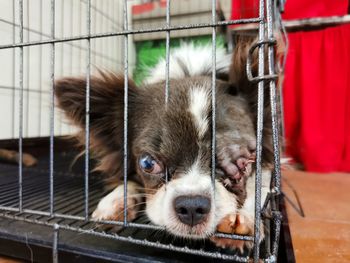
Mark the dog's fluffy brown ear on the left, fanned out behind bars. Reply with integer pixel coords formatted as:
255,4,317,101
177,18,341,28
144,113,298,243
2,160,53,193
55,72,137,179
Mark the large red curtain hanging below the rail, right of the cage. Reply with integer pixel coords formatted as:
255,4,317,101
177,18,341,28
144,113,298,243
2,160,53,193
284,25,350,172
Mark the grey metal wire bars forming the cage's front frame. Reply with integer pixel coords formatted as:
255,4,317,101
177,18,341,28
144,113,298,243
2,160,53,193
0,0,284,262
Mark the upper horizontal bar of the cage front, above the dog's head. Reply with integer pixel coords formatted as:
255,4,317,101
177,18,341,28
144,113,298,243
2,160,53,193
0,18,260,49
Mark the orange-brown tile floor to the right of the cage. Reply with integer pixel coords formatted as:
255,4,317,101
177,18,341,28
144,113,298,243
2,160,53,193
283,171,350,263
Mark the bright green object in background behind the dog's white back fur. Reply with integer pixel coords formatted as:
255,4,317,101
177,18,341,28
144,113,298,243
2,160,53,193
133,35,225,85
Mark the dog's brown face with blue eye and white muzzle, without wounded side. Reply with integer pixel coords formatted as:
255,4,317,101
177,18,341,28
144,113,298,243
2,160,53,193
132,77,241,238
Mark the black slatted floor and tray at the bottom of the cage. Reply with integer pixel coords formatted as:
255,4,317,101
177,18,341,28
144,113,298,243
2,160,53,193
0,139,292,262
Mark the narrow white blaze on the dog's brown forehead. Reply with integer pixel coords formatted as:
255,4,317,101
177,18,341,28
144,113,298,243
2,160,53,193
189,87,210,138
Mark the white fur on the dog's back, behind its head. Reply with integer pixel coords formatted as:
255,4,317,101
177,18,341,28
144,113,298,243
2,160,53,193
145,43,231,84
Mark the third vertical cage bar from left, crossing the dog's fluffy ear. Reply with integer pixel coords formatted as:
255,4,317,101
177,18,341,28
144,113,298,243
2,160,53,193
84,0,91,220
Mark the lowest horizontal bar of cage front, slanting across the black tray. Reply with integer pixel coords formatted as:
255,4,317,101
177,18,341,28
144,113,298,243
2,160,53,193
0,213,249,262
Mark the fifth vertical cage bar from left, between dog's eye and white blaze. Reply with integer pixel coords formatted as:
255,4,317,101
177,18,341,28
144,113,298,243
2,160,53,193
164,0,170,183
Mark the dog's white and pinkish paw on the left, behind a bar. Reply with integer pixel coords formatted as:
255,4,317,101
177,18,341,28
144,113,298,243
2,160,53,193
92,182,142,224
